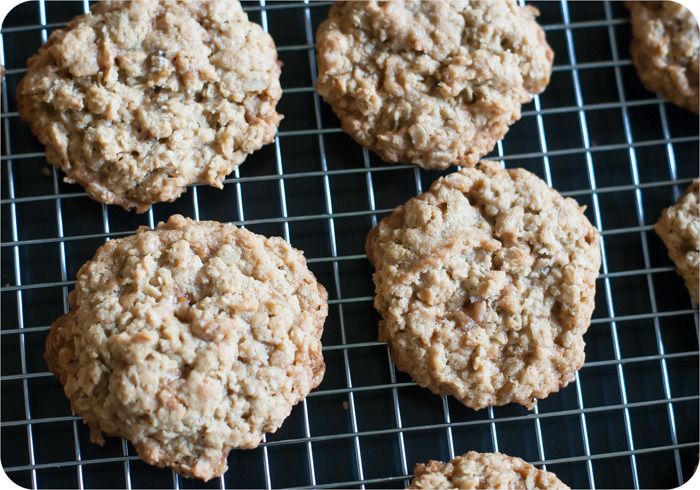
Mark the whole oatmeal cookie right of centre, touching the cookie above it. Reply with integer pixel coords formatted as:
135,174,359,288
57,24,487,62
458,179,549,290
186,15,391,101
366,161,600,409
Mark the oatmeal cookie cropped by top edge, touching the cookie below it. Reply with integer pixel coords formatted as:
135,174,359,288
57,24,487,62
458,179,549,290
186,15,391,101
316,0,553,169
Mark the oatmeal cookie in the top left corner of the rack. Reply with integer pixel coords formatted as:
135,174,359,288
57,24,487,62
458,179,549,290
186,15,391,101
17,0,282,212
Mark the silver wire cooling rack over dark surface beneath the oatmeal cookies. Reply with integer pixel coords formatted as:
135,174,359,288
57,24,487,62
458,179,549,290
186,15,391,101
0,1,698,488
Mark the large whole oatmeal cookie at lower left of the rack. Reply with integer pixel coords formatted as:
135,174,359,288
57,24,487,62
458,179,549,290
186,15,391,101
45,215,328,480
